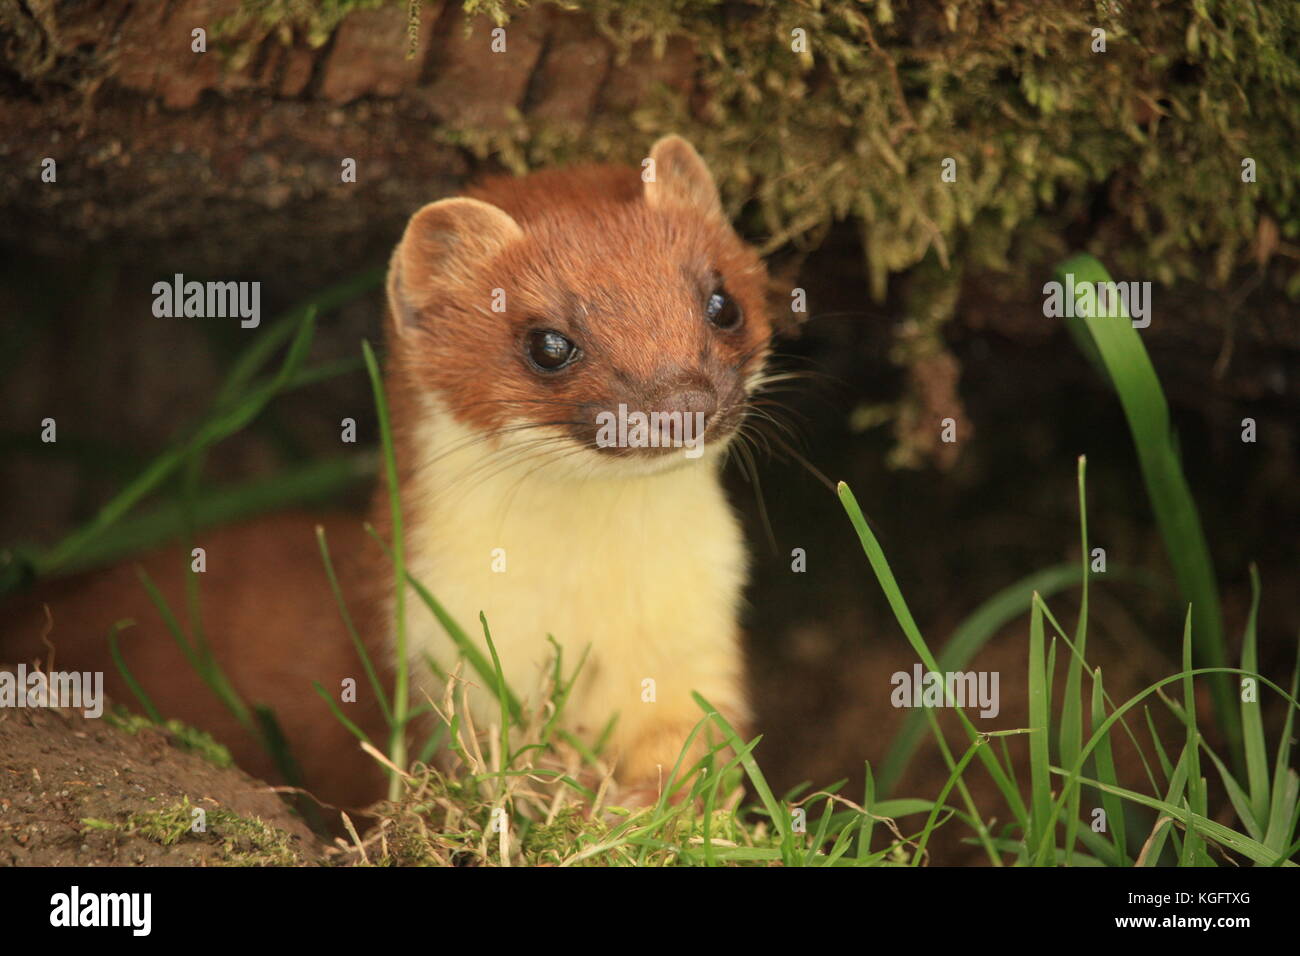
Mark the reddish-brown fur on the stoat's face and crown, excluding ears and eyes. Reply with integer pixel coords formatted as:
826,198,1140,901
390,159,771,440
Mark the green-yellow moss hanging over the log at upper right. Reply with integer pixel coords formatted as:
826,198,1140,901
228,0,1300,299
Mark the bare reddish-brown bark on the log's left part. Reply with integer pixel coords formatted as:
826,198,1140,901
0,0,694,289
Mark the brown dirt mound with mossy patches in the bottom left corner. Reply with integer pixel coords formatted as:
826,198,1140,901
0,708,325,866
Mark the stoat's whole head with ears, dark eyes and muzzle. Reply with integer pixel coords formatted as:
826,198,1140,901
387,137,771,472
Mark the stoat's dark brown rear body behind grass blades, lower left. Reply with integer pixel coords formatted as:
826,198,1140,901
0,514,385,808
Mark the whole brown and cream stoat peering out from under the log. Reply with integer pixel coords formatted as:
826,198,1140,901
0,137,770,806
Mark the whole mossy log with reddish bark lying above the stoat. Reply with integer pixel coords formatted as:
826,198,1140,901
0,0,1300,416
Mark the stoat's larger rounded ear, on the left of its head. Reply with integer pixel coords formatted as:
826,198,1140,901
387,198,524,333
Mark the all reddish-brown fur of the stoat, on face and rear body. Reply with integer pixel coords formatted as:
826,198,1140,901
0,138,770,808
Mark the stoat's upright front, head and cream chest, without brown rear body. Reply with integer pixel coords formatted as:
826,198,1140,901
377,137,770,783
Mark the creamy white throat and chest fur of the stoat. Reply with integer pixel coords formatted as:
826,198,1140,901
390,410,748,774
